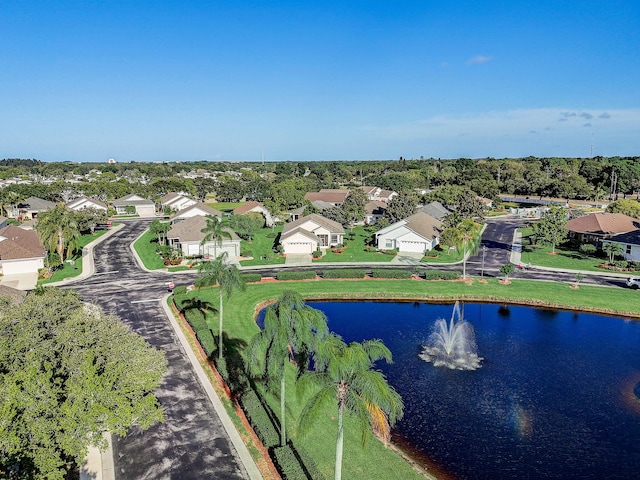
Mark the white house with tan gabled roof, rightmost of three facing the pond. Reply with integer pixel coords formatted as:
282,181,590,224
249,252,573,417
376,212,442,253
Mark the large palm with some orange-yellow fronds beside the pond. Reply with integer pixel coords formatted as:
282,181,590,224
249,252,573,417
298,335,404,480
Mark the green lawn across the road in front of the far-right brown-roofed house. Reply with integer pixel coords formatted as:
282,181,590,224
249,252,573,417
519,228,605,272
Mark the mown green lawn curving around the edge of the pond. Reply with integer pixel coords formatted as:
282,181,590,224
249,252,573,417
178,279,640,480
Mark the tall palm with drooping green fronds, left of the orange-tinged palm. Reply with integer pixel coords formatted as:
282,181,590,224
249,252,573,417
249,290,329,445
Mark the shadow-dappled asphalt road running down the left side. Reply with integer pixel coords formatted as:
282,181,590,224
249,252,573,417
70,220,248,480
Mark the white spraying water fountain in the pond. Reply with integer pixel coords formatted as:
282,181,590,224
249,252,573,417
420,302,482,370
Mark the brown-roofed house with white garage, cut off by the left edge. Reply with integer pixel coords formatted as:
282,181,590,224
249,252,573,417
0,225,46,289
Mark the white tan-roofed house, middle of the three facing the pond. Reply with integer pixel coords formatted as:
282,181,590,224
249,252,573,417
280,213,344,254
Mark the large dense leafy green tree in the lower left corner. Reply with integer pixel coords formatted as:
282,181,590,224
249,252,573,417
0,288,166,480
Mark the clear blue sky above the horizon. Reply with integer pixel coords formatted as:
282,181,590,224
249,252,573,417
0,0,640,162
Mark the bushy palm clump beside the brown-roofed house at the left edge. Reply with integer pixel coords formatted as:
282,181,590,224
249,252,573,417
36,205,80,261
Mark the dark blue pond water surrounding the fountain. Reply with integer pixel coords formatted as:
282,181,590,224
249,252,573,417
258,302,640,480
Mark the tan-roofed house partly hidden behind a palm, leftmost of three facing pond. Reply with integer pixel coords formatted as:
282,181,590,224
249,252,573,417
167,215,240,262
